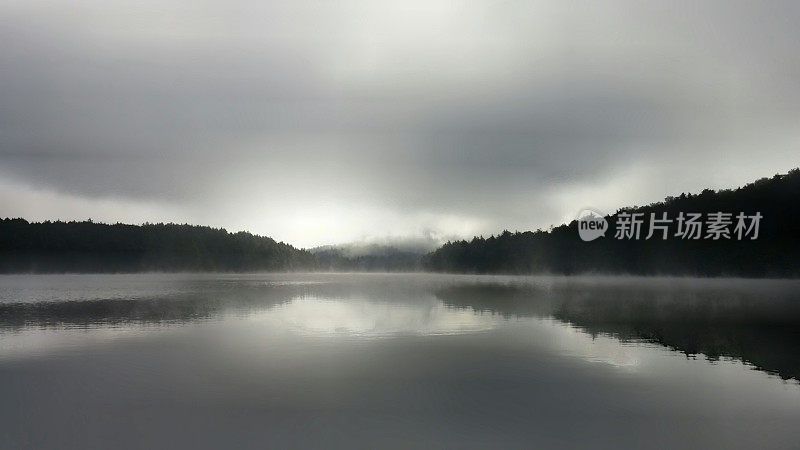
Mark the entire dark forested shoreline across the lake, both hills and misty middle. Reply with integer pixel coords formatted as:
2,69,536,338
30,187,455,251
0,169,800,277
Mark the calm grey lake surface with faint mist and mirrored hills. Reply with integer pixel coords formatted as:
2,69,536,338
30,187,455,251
0,274,800,448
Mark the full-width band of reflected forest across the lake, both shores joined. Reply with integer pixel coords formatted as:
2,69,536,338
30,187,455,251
6,276,800,380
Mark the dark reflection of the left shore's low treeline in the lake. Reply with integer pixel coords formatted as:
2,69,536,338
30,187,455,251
0,283,307,330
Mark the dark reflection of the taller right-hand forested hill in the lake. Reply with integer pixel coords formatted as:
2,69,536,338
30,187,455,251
437,279,800,380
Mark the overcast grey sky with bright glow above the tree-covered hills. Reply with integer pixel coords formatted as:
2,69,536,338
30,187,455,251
0,0,800,247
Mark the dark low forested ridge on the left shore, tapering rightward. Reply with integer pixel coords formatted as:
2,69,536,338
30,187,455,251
0,219,316,273
